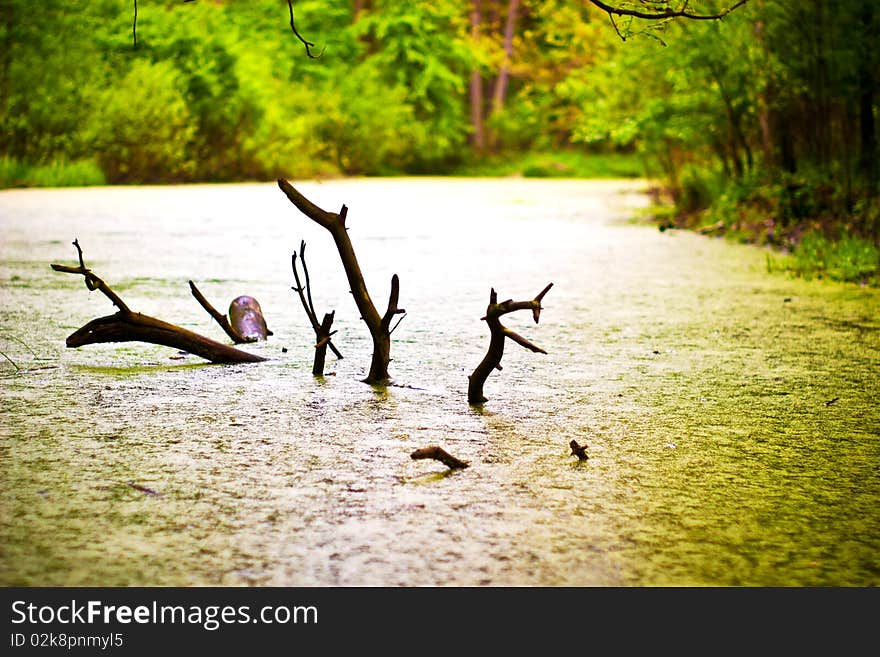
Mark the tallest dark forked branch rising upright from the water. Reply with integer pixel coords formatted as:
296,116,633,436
278,178,406,384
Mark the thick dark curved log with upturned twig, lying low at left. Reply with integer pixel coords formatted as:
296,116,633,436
52,240,266,363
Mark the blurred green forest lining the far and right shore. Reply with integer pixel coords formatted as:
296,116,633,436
0,0,880,284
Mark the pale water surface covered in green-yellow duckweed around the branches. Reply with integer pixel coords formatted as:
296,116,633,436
0,179,880,586
